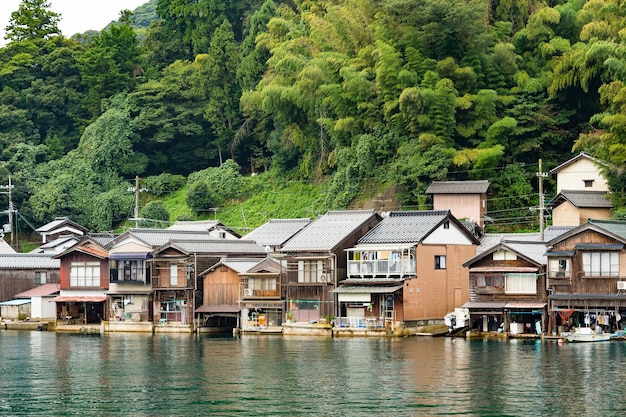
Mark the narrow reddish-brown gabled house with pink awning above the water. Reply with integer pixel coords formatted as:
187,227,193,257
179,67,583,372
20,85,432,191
52,237,109,324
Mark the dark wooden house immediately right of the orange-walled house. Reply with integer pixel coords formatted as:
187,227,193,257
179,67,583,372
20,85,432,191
462,240,548,334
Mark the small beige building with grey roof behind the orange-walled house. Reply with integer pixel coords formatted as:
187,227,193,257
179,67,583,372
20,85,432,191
426,180,491,227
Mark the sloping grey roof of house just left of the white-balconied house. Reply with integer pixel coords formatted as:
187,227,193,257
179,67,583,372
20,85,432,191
281,210,380,252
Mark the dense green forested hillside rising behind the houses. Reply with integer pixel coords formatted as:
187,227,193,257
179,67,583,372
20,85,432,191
0,0,626,236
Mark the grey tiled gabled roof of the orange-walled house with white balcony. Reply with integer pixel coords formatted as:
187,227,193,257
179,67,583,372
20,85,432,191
357,210,479,245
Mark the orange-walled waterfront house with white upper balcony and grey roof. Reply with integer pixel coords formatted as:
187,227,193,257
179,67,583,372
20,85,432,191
333,210,479,327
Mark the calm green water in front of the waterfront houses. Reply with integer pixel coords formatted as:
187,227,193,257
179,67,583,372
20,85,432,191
0,331,626,416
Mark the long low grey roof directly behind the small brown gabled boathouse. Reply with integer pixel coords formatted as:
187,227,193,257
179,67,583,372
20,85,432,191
152,237,265,257
